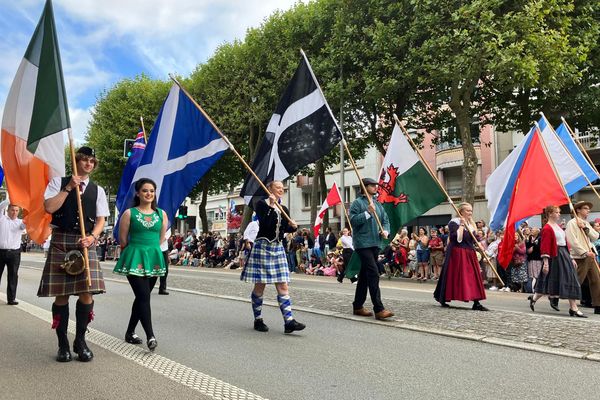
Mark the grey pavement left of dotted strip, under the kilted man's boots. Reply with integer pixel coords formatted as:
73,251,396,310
0,299,237,400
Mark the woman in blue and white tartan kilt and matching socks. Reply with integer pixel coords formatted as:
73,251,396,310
241,181,305,333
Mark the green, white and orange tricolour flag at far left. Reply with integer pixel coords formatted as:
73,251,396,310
1,0,71,243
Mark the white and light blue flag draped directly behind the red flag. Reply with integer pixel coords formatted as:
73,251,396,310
485,117,599,230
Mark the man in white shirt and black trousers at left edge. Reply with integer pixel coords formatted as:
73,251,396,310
0,199,25,306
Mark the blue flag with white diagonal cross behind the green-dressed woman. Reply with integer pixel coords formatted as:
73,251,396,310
115,85,228,239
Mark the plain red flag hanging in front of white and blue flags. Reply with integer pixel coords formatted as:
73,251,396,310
498,129,569,268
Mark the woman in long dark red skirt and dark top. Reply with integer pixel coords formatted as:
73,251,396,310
433,203,488,311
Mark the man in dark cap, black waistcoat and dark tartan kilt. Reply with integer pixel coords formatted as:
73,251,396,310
38,146,109,362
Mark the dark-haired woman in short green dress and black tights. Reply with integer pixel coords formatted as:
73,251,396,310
113,178,168,351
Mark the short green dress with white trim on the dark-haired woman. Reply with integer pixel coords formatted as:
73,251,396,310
113,207,167,276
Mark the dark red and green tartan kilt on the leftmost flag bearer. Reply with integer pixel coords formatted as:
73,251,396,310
38,231,106,297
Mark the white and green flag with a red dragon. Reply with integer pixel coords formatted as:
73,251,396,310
377,125,446,239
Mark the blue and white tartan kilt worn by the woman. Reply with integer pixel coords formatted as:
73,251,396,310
240,238,290,283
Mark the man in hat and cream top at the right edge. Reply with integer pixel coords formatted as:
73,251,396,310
566,201,600,314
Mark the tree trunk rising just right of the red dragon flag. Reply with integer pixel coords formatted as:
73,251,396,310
449,79,478,204
